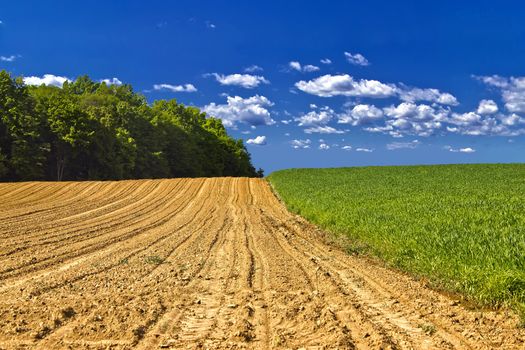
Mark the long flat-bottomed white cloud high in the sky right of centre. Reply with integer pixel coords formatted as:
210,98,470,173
295,74,396,98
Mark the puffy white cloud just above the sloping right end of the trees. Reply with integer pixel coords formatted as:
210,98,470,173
202,95,275,127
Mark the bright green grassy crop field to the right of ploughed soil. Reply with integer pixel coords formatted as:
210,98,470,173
268,164,525,319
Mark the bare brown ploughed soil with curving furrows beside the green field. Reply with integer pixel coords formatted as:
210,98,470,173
0,178,525,349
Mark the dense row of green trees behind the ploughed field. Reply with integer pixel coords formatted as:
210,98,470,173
0,70,262,181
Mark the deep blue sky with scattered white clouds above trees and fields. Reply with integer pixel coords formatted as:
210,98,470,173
0,0,525,173
